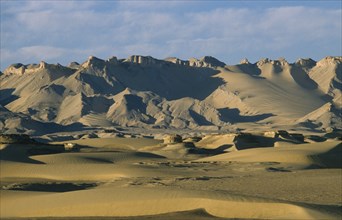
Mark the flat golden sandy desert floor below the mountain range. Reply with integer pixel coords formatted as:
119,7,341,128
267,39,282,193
0,135,342,219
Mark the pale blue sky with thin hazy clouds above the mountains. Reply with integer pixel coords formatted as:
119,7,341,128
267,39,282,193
0,0,342,70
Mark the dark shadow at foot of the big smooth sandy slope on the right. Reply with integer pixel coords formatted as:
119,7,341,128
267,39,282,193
218,108,274,123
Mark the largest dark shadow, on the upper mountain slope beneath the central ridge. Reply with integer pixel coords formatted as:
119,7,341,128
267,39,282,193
108,63,225,100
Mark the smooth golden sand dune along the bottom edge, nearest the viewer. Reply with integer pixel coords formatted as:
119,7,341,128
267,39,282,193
2,187,333,219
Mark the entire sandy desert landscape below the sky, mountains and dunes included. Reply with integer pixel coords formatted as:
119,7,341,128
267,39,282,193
0,55,342,219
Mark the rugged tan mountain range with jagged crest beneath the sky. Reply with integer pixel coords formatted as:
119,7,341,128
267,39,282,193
0,55,342,135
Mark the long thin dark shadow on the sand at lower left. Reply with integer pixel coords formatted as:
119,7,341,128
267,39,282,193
2,182,97,192
